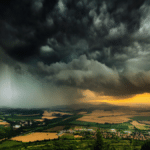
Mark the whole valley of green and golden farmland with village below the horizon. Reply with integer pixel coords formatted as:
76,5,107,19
0,107,149,150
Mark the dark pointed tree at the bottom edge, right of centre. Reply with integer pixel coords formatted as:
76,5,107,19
94,130,104,150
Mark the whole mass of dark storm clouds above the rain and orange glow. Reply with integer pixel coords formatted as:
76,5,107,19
0,0,150,99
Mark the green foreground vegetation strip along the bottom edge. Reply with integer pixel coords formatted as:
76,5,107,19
0,131,149,150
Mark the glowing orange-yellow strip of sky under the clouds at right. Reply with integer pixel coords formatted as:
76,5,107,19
80,90,150,106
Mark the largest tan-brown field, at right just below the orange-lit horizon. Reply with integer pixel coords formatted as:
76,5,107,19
77,110,150,124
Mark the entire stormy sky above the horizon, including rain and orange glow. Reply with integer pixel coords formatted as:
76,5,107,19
0,0,150,108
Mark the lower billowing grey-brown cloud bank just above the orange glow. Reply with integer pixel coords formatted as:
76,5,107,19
38,55,150,98
